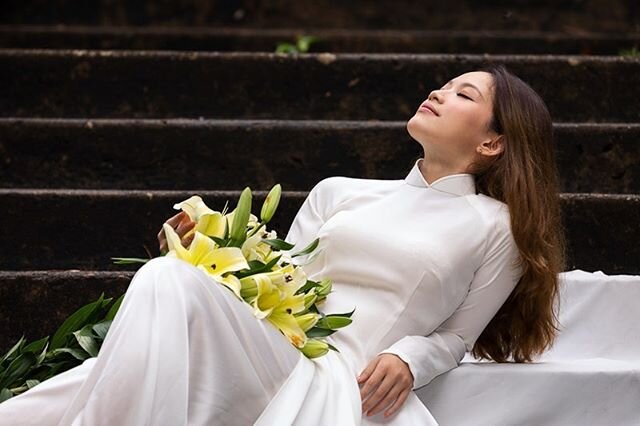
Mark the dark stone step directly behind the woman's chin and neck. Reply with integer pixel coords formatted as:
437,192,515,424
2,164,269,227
0,118,640,193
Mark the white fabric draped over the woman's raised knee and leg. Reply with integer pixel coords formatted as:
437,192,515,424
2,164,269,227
0,257,303,426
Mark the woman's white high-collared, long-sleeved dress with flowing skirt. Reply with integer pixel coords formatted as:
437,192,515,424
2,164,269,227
0,159,521,426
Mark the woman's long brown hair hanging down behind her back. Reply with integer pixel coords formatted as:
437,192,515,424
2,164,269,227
469,64,566,362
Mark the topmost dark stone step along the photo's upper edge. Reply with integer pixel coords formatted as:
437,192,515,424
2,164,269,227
0,0,640,32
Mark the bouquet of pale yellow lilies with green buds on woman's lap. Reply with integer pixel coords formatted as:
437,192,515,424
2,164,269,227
113,184,353,358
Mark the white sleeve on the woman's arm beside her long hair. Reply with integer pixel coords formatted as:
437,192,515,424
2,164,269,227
379,211,521,390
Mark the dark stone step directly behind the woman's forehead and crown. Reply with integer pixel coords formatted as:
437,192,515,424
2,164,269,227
0,49,640,122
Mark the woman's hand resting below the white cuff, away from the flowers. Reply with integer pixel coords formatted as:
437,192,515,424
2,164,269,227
358,353,414,417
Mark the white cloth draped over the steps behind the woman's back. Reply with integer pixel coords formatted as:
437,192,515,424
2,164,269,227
416,269,640,426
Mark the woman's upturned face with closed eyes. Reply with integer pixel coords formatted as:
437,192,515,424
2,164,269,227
407,71,497,167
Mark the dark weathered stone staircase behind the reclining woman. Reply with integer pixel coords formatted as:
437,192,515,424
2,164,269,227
0,0,640,392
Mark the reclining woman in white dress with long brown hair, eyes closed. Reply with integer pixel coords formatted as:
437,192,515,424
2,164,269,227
0,66,564,425
